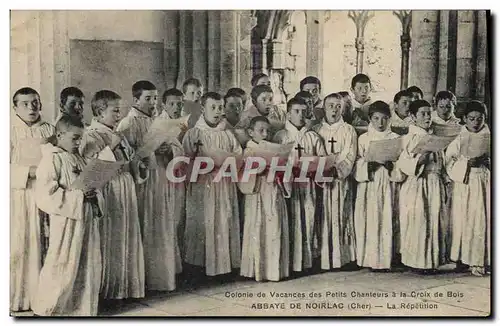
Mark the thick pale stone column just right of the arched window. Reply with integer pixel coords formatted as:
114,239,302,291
409,10,439,101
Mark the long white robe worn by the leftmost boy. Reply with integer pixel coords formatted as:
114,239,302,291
10,113,54,311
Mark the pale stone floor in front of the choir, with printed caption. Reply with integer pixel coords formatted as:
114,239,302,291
12,269,491,317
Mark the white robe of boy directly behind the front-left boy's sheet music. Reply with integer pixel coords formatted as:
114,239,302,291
80,119,145,299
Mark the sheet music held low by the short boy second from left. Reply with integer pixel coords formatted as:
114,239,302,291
71,159,127,190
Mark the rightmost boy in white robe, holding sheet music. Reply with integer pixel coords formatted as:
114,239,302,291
446,101,491,276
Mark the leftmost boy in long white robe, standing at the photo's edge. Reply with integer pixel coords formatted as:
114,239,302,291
10,87,54,311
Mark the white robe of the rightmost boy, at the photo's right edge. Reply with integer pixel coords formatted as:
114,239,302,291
445,125,491,267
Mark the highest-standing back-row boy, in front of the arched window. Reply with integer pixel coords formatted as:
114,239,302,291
351,74,373,126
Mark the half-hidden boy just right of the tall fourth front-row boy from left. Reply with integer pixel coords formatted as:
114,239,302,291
157,88,187,274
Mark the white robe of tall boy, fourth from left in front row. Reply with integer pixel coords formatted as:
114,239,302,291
116,107,176,291
